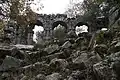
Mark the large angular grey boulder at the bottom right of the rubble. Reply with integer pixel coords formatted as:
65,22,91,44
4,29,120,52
93,62,117,80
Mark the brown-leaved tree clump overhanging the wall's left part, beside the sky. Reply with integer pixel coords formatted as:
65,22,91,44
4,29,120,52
9,0,36,26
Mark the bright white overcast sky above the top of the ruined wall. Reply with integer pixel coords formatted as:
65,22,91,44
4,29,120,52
32,0,83,14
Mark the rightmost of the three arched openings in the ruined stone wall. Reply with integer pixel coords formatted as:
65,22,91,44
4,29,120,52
75,22,89,35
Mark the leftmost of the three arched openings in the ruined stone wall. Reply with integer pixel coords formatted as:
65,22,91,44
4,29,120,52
33,20,44,43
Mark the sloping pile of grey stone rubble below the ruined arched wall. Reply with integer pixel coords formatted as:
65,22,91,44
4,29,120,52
0,24,120,80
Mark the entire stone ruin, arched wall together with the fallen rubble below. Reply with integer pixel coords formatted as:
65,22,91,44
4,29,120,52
0,6,120,80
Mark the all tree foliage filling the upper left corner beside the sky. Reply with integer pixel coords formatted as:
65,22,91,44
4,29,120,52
0,0,42,27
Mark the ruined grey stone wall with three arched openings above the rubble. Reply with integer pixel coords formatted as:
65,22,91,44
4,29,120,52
4,14,108,44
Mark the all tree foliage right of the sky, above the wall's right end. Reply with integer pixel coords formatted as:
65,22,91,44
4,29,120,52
66,0,120,20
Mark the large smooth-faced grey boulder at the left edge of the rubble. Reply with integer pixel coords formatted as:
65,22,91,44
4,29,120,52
0,56,22,71
